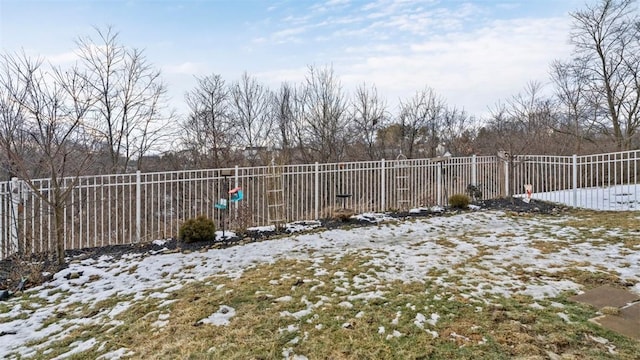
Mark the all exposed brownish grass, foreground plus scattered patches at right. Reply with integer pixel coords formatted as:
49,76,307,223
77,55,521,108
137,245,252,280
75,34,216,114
5,213,640,359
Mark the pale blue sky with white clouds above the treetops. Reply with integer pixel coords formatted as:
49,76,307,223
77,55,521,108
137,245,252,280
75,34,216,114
0,0,595,116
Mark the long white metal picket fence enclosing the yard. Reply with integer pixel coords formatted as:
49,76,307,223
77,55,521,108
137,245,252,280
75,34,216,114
0,151,640,259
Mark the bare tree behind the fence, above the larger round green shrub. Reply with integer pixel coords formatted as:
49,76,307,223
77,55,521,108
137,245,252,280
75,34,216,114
182,75,232,167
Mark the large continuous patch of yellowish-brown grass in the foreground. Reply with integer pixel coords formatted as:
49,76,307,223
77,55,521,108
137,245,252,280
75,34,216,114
61,256,640,359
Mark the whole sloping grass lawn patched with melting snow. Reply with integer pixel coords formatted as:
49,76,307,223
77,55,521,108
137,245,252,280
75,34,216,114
0,211,640,359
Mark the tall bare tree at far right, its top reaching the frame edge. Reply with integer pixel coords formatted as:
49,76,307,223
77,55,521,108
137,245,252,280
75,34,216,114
571,0,640,150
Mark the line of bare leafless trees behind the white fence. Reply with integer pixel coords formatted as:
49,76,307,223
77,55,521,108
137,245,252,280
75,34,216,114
0,0,640,179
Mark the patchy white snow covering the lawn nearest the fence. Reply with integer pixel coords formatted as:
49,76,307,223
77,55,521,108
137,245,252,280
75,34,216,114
0,195,640,359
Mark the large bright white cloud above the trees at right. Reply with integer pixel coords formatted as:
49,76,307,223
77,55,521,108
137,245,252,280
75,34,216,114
336,18,570,114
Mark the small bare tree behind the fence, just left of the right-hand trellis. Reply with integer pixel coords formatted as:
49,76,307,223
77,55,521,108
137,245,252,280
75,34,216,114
351,84,389,160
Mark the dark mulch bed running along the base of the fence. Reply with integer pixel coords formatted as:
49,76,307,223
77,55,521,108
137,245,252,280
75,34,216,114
0,198,568,291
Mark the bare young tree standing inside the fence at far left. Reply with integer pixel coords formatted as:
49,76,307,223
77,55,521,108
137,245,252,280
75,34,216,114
0,51,94,264
